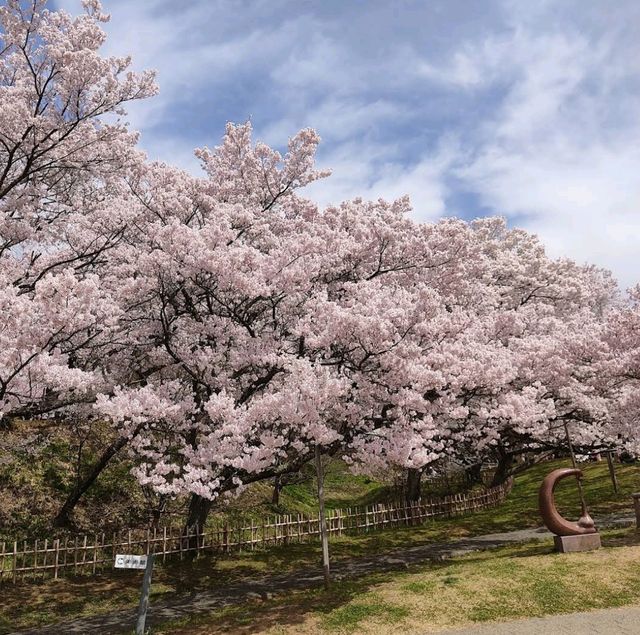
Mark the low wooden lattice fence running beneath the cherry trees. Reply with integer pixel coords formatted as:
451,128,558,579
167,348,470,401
0,480,512,583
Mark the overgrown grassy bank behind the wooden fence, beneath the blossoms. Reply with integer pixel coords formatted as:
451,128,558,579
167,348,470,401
0,421,390,542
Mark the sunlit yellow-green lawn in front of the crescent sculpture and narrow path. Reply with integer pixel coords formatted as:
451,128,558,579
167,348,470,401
153,530,640,635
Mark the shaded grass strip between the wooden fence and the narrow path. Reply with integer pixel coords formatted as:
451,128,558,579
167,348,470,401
0,461,640,632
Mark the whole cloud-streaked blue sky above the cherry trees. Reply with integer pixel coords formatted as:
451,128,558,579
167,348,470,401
54,0,640,286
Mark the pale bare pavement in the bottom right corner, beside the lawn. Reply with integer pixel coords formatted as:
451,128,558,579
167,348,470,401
442,607,640,635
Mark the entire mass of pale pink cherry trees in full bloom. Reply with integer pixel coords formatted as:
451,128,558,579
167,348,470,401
0,0,640,526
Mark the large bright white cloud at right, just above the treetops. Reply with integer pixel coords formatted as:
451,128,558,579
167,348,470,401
438,6,640,286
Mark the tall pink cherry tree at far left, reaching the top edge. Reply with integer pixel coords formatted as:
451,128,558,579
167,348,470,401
0,0,155,422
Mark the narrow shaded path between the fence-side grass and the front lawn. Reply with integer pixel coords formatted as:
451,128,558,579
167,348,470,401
12,516,640,635
